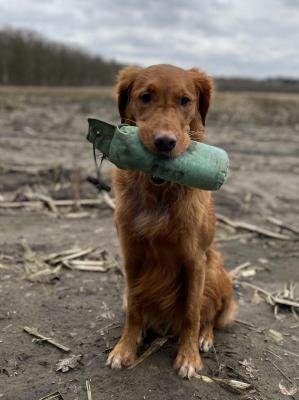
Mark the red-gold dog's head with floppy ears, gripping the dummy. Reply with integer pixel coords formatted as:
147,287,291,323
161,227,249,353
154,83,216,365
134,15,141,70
116,64,213,157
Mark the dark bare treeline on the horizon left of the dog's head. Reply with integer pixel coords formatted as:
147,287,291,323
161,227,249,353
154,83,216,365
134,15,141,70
0,29,121,86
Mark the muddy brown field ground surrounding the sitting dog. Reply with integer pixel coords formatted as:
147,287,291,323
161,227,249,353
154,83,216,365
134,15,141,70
0,88,299,400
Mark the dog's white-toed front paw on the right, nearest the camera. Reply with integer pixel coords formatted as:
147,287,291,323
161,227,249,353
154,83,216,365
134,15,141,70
174,350,202,379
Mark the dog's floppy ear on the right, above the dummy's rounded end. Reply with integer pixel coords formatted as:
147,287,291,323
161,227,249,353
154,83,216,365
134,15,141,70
189,68,214,125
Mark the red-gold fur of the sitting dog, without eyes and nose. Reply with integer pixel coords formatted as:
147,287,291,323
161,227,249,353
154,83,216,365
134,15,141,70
108,65,235,378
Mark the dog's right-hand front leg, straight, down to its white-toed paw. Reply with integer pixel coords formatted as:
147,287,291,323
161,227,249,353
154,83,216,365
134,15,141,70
175,255,205,378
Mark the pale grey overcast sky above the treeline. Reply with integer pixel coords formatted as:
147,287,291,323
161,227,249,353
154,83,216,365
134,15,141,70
0,0,299,78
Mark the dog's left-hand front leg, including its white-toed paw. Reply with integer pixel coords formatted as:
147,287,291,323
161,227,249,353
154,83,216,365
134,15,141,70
107,239,142,368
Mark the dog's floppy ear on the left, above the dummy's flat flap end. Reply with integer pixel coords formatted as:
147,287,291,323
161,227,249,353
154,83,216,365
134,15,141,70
115,67,141,123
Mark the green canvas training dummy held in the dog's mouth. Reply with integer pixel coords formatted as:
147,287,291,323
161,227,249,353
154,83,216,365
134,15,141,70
87,118,229,190
